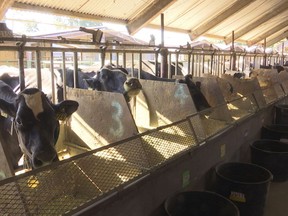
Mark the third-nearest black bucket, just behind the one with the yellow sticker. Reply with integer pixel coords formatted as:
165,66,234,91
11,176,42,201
250,139,288,181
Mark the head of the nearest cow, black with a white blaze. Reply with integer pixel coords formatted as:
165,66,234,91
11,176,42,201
0,88,79,168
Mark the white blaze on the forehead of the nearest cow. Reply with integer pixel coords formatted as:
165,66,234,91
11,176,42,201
23,92,44,120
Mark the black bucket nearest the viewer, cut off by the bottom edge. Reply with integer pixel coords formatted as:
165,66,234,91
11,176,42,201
164,191,240,216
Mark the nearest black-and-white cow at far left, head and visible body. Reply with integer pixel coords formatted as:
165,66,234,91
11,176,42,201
0,81,79,168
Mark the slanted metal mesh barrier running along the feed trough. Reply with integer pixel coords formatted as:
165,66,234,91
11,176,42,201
0,67,288,216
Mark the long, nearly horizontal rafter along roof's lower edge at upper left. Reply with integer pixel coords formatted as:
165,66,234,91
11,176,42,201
12,2,127,25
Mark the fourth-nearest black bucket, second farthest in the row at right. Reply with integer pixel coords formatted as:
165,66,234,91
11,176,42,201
261,124,288,140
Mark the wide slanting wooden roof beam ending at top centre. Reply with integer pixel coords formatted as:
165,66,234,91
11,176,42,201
126,0,177,35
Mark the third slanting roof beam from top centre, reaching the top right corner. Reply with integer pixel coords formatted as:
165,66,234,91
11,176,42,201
225,1,288,44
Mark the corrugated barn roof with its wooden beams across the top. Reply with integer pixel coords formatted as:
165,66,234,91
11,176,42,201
0,0,288,46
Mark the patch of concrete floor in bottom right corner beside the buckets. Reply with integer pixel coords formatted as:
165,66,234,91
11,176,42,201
264,181,288,216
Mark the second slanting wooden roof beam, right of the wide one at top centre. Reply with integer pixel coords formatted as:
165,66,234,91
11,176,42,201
189,0,255,40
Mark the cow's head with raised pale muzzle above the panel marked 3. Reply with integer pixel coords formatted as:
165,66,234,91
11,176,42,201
85,67,142,102
